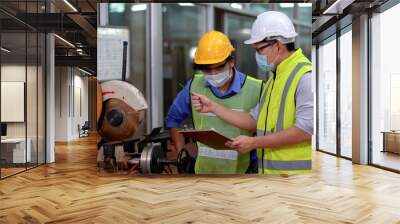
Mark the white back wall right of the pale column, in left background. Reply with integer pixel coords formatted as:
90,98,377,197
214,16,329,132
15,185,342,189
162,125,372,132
55,67,88,141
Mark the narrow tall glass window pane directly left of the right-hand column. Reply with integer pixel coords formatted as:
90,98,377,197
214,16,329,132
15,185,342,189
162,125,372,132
340,27,353,158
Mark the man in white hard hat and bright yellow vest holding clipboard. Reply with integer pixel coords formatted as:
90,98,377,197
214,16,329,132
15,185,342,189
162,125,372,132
192,11,314,174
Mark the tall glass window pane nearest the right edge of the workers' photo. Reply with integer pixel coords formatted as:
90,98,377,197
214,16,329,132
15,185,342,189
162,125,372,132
317,36,337,153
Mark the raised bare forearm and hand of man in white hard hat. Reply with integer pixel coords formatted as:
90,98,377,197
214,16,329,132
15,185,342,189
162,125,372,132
192,93,257,132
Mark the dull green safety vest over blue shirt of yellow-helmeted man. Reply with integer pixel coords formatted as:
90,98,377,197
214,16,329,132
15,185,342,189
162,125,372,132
190,74,263,174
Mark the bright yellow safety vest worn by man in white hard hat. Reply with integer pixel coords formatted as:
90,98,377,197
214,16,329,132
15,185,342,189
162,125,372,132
257,49,312,174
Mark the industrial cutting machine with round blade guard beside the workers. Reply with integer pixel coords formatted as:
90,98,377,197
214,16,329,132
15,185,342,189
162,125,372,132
97,42,195,174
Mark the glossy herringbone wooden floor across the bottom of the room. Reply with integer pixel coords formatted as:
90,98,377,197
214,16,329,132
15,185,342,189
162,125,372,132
0,138,400,224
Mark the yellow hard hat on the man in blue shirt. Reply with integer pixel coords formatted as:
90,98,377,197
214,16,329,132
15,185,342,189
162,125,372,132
194,31,235,65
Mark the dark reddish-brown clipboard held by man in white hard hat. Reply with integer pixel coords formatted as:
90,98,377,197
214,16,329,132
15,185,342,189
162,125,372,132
179,129,232,150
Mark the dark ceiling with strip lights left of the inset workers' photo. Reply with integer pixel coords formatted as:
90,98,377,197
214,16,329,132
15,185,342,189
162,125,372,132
0,0,97,73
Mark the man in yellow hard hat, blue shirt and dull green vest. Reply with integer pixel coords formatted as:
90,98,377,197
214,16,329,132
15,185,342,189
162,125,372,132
166,31,263,174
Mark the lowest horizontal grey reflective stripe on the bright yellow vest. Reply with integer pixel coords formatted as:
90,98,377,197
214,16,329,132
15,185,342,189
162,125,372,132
258,159,312,170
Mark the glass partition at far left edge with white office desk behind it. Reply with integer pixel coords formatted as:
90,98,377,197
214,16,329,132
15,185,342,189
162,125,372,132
0,28,27,177
